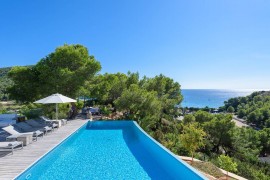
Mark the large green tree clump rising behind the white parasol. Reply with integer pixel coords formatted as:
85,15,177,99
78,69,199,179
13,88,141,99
8,45,101,102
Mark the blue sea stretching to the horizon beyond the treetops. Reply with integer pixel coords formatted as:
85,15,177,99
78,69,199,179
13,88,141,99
181,89,257,108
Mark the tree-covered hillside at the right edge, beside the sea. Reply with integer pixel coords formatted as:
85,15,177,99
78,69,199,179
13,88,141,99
224,91,270,128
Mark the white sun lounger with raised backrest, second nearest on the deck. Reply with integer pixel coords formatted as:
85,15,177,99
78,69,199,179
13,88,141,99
2,125,44,140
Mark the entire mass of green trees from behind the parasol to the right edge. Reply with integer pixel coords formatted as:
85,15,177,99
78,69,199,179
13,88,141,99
4,45,270,179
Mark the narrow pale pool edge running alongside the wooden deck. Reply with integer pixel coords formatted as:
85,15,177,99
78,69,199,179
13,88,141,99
13,119,87,179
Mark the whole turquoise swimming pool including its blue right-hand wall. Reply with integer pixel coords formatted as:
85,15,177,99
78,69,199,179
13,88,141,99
16,121,206,179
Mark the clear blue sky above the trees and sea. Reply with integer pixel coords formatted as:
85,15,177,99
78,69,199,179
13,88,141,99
0,0,270,89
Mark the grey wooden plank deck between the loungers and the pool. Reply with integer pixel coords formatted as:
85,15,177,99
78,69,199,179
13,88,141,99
0,119,87,180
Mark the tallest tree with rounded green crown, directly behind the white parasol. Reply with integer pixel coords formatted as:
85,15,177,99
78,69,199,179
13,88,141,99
35,45,101,97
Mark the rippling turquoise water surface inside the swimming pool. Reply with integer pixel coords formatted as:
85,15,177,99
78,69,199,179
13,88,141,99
18,121,206,180
